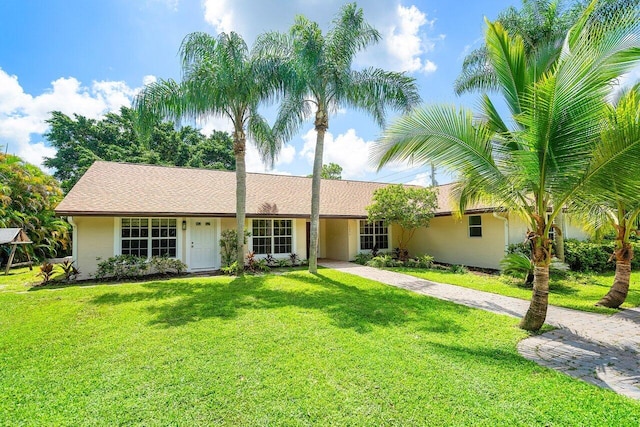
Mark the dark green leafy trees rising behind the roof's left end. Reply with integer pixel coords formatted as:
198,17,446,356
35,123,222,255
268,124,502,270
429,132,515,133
44,107,235,192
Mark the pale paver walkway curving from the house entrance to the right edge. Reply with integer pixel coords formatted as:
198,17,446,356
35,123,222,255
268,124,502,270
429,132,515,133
320,260,640,400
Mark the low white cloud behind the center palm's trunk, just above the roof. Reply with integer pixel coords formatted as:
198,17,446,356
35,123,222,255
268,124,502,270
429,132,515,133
300,129,375,179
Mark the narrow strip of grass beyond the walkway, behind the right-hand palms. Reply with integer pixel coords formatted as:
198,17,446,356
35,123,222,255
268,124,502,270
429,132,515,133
390,268,640,314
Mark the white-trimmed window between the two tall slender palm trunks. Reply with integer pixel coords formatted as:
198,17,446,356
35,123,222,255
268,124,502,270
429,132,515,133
251,219,293,255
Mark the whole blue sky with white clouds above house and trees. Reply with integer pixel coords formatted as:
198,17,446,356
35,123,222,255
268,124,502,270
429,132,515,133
0,0,536,184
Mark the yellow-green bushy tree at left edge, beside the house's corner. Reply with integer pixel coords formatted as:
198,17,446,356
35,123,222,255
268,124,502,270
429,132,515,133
0,153,70,260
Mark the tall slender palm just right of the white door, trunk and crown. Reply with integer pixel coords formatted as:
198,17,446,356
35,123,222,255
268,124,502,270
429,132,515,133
135,32,280,274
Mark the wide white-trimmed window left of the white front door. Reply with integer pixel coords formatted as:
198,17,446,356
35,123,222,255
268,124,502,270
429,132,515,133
120,218,178,258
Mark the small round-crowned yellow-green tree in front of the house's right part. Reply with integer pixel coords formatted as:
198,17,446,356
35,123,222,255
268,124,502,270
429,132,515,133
367,184,438,261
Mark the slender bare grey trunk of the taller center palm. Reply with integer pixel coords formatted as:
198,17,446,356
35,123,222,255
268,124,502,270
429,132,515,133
309,105,329,274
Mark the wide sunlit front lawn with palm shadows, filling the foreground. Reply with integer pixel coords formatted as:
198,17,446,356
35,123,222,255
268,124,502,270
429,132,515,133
0,269,640,426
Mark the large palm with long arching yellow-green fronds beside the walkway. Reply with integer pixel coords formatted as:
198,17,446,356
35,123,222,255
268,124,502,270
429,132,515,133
375,1,640,331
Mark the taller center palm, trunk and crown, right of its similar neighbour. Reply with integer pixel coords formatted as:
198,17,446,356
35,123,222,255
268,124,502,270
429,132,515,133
256,3,420,273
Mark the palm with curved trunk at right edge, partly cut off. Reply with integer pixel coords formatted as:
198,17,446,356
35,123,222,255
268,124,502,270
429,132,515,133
572,84,640,308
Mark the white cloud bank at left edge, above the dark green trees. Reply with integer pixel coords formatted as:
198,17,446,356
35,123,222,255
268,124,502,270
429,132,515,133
0,68,145,166
